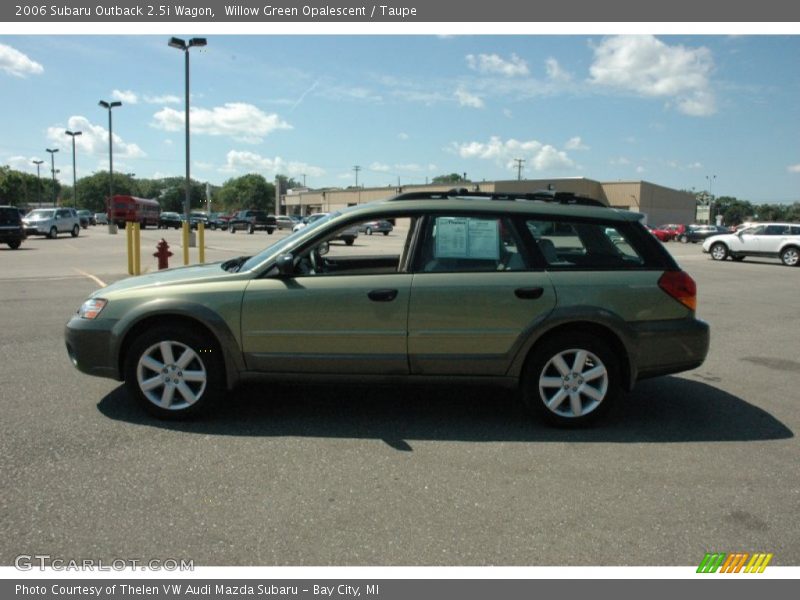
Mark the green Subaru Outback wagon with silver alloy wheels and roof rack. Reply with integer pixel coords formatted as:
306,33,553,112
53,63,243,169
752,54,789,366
66,190,709,425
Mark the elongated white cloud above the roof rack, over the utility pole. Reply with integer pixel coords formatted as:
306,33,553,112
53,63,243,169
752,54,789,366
451,136,575,171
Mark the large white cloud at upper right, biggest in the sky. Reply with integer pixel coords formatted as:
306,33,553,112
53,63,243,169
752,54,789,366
589,35,716,116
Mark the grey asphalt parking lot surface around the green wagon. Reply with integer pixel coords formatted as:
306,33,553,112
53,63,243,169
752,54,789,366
0,227,800,565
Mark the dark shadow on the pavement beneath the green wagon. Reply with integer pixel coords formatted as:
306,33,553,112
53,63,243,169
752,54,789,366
98,374,794,451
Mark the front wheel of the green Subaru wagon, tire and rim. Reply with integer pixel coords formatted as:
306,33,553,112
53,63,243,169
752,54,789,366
125,326,225,420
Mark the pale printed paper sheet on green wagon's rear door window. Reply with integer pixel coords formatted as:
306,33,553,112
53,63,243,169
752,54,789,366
435,217,500,260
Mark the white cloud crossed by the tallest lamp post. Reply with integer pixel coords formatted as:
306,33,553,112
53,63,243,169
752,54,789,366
153,102,292,144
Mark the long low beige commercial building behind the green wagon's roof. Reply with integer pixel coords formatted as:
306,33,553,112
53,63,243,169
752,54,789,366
280,177,696,225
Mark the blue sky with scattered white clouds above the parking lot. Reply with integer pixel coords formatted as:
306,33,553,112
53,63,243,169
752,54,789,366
0,34,800,203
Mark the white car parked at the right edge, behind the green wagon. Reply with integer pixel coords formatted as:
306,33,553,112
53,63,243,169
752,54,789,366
703,223,800,267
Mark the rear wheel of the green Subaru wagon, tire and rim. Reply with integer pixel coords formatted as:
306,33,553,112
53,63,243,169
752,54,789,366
522,332,620,427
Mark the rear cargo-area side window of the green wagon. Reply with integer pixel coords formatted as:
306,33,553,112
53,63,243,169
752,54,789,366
526,220,645,270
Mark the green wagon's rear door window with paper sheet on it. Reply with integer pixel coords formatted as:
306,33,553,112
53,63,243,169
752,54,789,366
417,215,528,273
